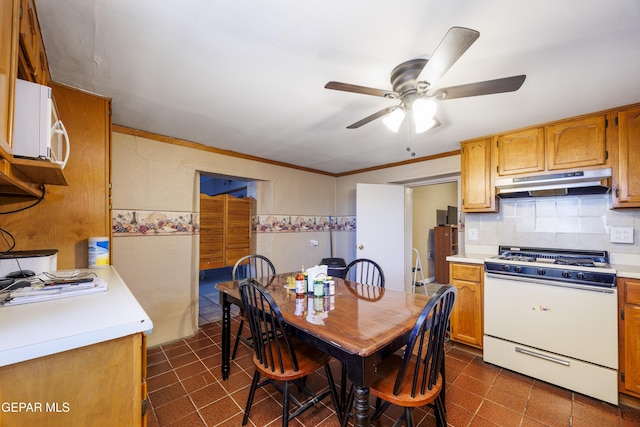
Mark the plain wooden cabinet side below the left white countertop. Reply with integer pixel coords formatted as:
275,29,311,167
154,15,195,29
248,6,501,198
0,333,147,427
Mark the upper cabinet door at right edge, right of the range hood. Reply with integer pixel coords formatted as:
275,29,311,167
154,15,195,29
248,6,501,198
613,107,640,207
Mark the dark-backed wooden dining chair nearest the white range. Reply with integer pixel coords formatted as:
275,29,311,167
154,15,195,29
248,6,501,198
342,285,457,427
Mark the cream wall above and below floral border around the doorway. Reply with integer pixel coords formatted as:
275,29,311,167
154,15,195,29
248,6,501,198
112,132,335,345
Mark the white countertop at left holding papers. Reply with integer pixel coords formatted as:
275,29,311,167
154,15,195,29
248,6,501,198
0,266,153,366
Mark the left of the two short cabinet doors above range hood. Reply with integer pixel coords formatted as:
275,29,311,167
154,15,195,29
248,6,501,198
496,128,544,175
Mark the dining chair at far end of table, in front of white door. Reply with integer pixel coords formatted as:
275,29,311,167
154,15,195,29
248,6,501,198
340,258,384,410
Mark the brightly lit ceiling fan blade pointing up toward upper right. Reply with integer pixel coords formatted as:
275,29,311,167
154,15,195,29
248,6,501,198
418,27,480,87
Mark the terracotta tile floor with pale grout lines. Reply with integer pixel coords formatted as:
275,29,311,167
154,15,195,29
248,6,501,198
147,318,640,427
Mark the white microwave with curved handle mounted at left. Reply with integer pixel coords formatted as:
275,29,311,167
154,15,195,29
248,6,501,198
12,79,70,168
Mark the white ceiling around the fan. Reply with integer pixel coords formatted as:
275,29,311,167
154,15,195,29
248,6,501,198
36,0,640,173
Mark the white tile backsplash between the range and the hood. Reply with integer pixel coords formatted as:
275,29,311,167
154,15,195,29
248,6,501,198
464,194,640,253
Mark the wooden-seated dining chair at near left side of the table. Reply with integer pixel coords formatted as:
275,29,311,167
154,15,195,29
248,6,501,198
238,279,341,426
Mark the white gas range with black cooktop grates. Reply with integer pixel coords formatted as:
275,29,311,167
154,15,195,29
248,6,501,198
483,246,618,405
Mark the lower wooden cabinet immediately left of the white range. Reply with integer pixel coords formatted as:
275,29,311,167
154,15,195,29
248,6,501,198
449,262,484,348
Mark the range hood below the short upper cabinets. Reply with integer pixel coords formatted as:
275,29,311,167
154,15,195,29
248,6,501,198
495,168,611,199
